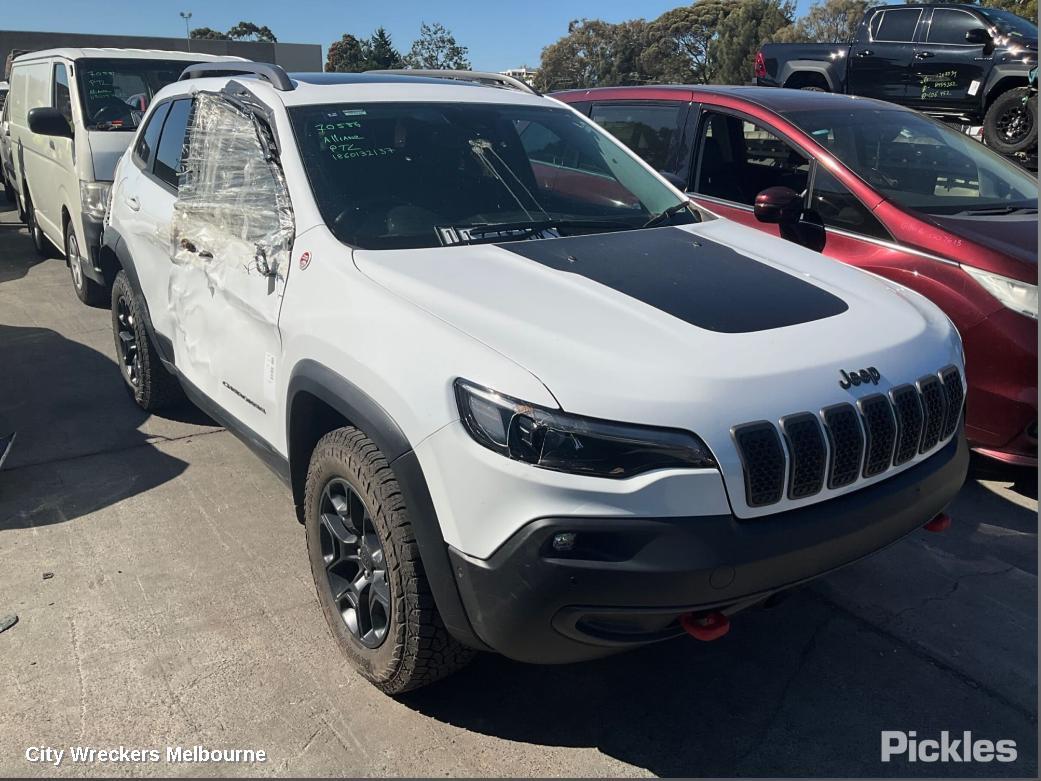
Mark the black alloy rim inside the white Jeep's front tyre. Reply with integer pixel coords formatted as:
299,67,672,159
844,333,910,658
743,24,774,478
319,478,391,648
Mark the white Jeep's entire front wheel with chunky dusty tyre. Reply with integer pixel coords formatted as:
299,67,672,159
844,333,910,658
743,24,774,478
304,426,475,695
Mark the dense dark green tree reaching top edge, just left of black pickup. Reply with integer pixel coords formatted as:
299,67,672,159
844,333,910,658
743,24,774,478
708,0,795,84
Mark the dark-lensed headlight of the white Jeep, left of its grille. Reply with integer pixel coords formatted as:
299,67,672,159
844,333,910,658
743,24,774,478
455,379,718,478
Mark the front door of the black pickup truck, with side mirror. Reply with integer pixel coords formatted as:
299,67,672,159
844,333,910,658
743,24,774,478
907,8,993,112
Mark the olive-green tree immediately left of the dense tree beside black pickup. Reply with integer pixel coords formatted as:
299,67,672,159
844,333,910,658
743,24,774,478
640,0,732,83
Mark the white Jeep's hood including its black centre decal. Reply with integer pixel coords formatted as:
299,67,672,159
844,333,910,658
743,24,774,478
354,220,961,517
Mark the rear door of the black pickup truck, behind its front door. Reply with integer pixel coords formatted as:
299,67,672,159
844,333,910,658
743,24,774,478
846,6,925,103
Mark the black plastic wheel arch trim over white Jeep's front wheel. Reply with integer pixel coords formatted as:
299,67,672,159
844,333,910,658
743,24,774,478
286,358,489,651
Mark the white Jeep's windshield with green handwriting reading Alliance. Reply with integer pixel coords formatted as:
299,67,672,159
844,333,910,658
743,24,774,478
289,103,697,249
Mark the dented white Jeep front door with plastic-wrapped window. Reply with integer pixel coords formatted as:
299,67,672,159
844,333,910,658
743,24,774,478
169,94,294,444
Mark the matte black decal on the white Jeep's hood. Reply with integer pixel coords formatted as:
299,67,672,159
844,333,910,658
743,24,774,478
497,228,849,333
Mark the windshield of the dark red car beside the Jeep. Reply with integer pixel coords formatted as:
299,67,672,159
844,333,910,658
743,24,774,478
785,105,1038,215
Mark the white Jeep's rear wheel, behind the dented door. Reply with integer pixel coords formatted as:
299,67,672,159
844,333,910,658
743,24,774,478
112,271,183,412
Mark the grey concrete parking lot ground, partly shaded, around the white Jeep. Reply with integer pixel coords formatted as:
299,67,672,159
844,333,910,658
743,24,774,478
0,198,1038,777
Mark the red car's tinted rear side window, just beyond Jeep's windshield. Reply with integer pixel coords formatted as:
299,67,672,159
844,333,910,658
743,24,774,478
589,100,691,185
